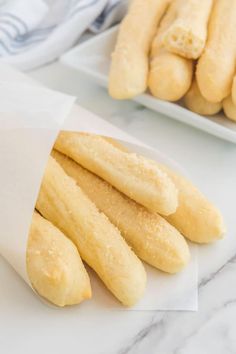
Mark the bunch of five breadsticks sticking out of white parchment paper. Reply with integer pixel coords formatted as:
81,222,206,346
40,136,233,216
27,132,224,306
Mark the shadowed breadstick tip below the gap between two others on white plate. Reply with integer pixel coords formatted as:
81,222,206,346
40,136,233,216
184,80,222,116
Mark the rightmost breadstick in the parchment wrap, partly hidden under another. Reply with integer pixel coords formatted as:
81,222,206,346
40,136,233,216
104,137,225,243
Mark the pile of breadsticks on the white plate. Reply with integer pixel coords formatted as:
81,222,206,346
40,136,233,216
109,0,236,120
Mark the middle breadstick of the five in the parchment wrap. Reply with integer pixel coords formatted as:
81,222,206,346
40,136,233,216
52,150,190,273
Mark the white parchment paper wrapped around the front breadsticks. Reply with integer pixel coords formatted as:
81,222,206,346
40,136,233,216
0,64,198,311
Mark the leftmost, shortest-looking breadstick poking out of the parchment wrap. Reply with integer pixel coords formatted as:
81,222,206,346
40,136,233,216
26,212,91,306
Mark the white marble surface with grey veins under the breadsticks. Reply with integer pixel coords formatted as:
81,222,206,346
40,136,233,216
0,63,236,354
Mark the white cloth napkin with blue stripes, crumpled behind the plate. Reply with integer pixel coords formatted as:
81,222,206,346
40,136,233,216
0,0,128,70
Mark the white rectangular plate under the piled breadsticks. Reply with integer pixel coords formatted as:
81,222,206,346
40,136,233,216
61,26,236,143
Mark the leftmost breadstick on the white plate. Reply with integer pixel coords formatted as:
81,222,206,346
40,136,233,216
109,0,170,99
